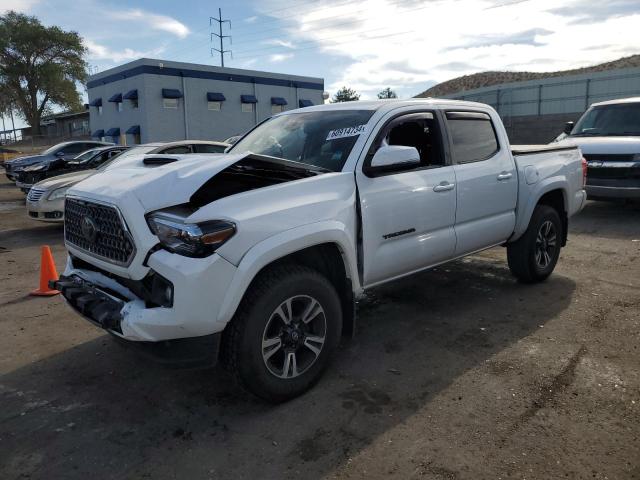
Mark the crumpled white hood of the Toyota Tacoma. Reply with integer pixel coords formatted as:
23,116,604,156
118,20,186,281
68,153,249,212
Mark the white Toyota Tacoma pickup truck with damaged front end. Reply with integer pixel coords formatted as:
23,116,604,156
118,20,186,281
52,99,586,402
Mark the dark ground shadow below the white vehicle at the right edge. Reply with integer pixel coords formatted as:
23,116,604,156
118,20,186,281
569,201,640,239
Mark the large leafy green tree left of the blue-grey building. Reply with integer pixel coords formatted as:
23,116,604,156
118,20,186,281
0,11,87,134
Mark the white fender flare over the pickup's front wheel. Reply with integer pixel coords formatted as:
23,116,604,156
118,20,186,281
216,221,360,325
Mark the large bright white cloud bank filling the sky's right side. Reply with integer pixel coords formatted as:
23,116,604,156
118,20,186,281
255,0,640,98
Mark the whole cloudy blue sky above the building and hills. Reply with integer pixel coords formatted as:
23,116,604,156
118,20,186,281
0,0,640,103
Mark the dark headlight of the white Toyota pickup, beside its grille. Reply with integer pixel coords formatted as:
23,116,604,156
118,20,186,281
147,214,236,258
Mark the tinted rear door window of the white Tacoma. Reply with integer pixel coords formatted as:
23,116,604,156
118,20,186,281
447,112,500,163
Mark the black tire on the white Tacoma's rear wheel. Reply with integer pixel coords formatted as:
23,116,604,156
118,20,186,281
507,205,563,283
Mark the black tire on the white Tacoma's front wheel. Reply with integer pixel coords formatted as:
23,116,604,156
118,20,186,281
222,265,342,403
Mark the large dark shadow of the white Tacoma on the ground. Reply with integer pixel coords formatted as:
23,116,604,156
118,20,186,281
0,257,575,479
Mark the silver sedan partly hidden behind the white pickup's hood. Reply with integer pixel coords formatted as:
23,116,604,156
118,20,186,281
27,140,229,222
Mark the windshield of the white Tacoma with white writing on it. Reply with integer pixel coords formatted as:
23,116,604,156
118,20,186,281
229,110,374,172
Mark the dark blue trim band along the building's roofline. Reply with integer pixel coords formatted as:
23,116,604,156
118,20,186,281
87,65,324,90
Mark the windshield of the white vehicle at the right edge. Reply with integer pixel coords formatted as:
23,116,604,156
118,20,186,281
571,103,640,137
